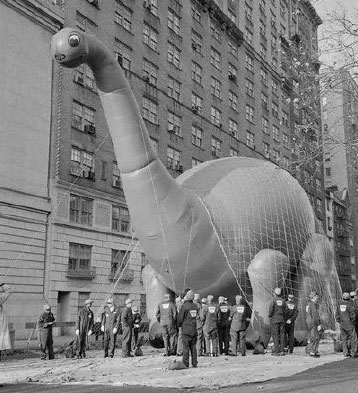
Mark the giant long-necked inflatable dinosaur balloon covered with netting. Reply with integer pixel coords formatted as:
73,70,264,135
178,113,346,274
52,28,340,341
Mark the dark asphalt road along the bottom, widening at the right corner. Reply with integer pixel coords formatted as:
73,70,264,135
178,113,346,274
0,358,358,393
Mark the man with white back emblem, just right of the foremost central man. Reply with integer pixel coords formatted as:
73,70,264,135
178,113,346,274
203,295,219,356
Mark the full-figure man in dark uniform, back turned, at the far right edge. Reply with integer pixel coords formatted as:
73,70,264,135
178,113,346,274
336,292,357,358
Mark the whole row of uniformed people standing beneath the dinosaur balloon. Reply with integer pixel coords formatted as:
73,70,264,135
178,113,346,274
0,285,358,367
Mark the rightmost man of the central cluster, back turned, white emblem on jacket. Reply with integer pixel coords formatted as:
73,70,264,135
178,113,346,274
230,295,251,356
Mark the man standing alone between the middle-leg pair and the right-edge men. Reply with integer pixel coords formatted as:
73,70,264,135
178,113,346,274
306,291,323,358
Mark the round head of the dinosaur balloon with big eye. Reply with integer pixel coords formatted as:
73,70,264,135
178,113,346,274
51,28,88,68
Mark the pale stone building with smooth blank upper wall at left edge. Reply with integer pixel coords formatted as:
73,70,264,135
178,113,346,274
0,0,63,337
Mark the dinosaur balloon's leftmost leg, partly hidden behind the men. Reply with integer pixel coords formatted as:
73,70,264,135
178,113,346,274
142,265,174,348
